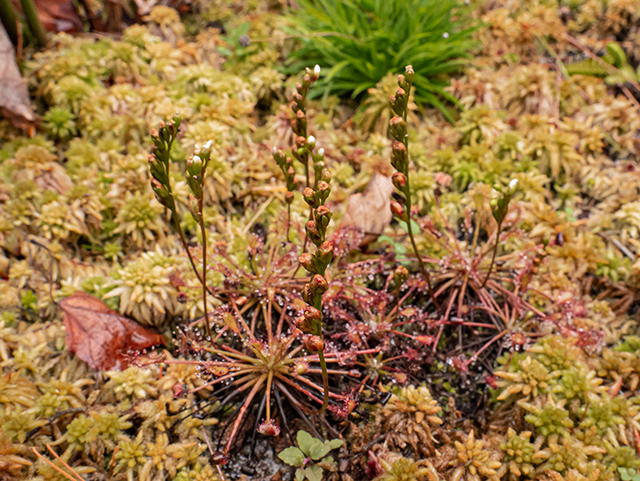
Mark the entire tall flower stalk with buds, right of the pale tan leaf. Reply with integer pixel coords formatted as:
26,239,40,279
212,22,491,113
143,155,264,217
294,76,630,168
389,65,438,307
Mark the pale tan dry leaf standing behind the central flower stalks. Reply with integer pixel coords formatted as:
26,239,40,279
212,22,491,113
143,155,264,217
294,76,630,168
338,173,394,247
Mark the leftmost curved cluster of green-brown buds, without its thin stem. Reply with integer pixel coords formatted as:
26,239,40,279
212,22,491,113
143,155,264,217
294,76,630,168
148,116,182,213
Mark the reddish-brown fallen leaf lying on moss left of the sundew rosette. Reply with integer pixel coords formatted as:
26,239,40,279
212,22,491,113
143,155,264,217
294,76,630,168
60,291,164,371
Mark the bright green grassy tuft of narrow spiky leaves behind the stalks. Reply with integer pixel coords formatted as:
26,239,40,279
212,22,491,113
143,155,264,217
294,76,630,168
289,0,476,121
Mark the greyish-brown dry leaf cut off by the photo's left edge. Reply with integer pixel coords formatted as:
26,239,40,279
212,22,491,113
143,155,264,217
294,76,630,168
0,23,36,130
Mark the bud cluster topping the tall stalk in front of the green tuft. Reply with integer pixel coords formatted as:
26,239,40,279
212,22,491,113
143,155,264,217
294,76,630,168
389,65,415,221
